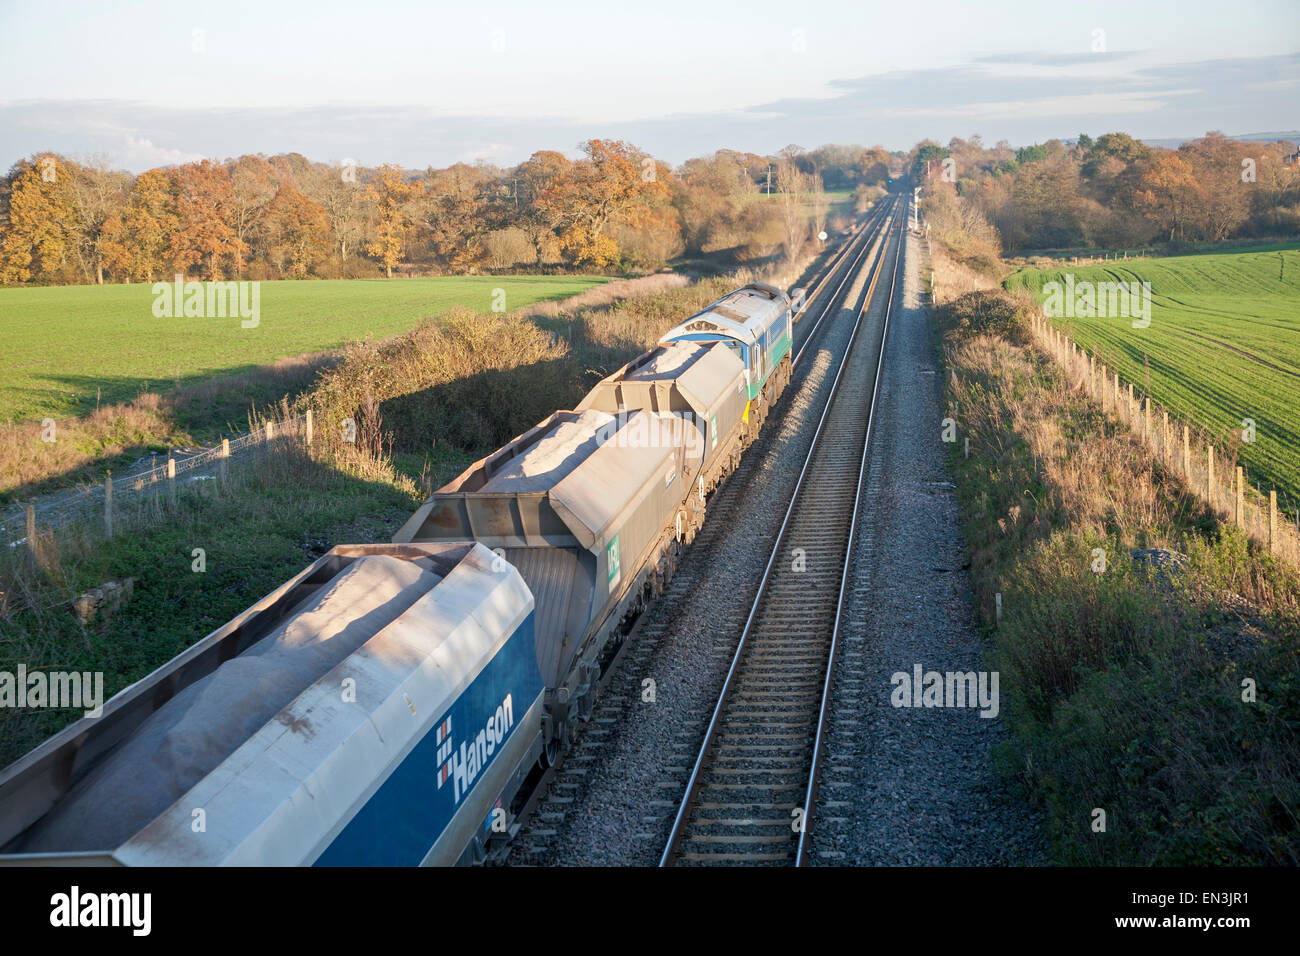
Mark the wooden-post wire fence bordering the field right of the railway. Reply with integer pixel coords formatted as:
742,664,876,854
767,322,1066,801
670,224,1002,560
1032,316,1300,564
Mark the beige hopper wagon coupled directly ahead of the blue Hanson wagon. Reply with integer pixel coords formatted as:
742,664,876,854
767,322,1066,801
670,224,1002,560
394,408,698,757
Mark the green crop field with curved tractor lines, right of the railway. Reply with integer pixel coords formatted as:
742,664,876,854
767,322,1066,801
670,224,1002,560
1006,243,1300,510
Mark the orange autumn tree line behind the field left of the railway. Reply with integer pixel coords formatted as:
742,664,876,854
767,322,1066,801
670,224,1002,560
0,139,901,284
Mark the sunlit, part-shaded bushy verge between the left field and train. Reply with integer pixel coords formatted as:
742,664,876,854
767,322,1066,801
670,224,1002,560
309,272,785,468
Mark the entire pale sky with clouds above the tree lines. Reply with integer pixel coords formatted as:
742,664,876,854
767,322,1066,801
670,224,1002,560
0,0,1300,172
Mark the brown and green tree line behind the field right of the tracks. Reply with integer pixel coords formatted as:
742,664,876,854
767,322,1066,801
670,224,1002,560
911,131,1300,259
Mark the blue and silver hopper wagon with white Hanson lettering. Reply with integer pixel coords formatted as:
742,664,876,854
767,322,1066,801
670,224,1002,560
0,541,543,866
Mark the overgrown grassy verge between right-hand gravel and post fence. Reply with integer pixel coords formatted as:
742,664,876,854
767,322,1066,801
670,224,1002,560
936,290,1300,865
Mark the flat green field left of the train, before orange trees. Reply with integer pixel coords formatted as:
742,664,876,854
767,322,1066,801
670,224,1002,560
0,276,607,421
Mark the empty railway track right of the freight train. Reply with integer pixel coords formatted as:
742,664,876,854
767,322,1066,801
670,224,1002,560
660,197,905,865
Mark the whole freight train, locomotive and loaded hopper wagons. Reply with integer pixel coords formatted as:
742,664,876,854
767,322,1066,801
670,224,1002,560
0,282,793,866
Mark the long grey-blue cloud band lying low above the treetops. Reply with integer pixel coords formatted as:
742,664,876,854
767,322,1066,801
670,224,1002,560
0,52,1300,172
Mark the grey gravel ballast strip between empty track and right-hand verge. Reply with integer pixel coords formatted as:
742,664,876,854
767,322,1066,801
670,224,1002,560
813,226,1045,865
